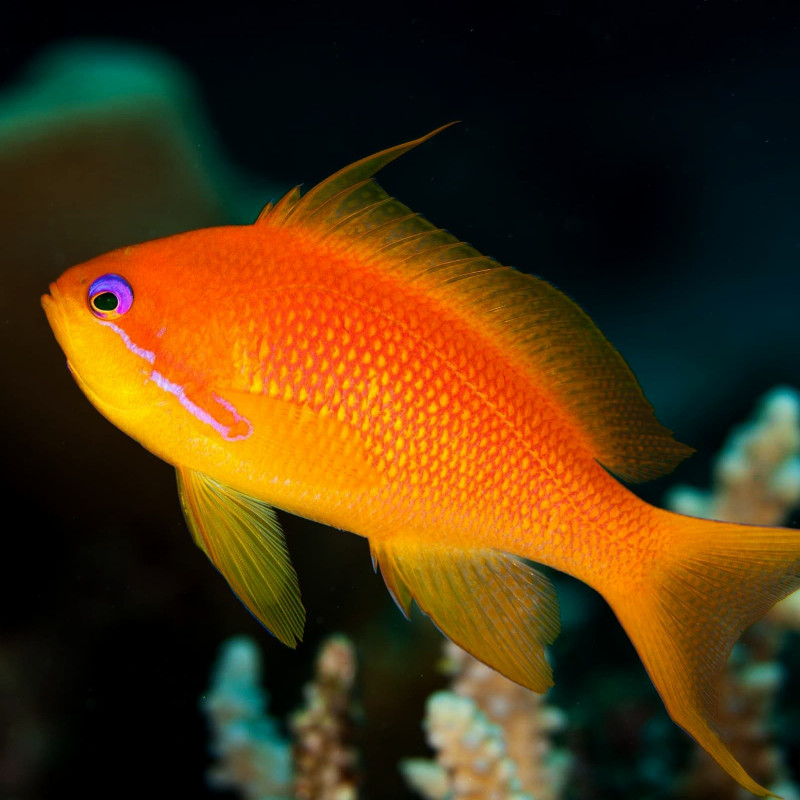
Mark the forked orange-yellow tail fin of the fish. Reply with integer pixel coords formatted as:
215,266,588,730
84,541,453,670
601,511,800,797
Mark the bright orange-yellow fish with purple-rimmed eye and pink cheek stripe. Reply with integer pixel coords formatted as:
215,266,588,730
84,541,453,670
42,126,800,797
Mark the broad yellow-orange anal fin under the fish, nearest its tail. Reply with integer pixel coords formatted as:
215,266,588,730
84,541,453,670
370,538,560,692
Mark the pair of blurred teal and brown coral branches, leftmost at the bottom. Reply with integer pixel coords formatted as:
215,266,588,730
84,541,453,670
200,636,357,800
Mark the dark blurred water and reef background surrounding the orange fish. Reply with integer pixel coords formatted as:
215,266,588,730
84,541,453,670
0,0,800,800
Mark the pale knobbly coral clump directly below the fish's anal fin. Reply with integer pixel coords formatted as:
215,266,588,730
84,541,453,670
401,642,571,800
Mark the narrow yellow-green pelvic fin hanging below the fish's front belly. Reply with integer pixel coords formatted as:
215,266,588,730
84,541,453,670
177,468,305,647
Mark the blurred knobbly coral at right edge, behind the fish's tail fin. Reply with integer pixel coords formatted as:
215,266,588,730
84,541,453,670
667,388,800,800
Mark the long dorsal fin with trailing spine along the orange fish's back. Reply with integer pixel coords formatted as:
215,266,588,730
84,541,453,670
259,128,692,481
